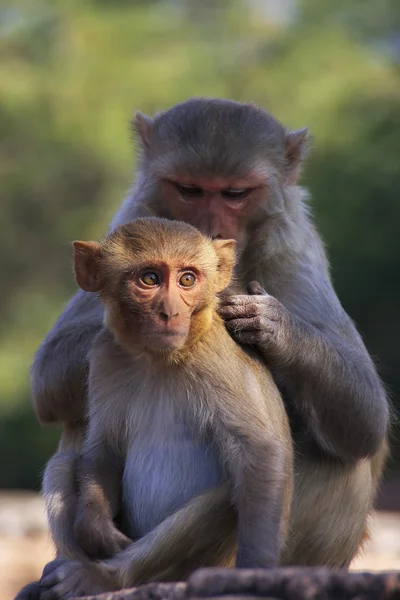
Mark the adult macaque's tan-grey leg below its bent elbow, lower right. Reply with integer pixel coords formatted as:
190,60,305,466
280,456,376,567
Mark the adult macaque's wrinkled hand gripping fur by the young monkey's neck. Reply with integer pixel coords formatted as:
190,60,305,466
218,281,292,360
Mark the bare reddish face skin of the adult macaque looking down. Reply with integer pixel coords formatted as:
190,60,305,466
162,174,266,250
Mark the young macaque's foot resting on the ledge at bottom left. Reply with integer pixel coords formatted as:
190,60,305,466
40,558,119,600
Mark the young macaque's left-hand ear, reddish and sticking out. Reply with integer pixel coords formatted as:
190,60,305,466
72,242,102,292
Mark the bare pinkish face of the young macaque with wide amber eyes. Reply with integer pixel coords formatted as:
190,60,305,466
121,262,204,350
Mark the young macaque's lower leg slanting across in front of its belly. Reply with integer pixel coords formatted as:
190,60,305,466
106,484,237,587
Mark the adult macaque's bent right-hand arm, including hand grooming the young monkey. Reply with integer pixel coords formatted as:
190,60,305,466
221,281,389,460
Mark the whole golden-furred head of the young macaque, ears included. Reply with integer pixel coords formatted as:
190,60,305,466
73,217,235,355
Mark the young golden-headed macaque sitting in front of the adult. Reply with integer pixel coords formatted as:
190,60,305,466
41,218,293,600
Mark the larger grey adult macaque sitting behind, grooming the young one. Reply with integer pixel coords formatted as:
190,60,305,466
32,99,388,566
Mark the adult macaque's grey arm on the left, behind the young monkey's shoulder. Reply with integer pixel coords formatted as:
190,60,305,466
31,290,103,424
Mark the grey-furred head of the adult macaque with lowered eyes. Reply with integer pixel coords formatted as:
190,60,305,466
116,99,308,253
